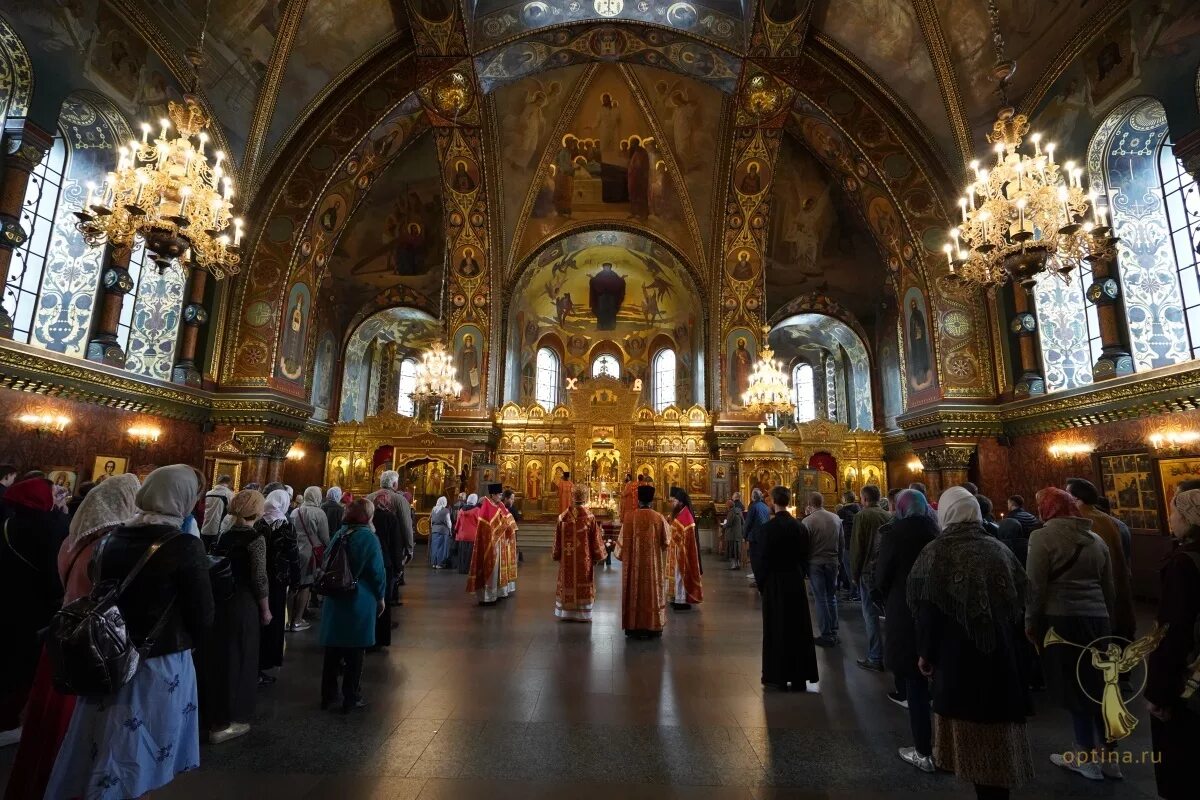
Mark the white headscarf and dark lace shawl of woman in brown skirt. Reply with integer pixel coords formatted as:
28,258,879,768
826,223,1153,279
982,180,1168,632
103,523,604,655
907,486,1027,654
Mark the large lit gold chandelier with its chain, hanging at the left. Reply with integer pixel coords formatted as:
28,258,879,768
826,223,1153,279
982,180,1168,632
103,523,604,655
76,0,242,279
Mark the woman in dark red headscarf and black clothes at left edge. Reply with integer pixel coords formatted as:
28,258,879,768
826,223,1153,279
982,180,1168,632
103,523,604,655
0,477,67,736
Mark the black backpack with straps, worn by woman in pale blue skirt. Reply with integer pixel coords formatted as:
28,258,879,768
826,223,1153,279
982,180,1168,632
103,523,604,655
46,531,180,697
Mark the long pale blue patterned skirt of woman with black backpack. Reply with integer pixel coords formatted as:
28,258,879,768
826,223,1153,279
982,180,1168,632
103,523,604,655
46,650,200,800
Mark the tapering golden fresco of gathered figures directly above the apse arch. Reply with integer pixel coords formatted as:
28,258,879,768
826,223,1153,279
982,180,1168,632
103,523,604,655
514,65,700,262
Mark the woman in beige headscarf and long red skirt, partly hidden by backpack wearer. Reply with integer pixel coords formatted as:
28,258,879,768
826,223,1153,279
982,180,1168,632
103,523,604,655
5,473,138,800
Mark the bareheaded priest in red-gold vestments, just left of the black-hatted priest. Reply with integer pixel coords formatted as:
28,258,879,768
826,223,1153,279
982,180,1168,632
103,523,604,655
553,486,606,622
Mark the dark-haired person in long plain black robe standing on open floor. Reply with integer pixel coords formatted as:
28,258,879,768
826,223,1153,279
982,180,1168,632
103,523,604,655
755,486,818,692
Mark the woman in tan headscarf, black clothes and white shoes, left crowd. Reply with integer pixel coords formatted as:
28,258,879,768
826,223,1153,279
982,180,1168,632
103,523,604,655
197,489,271,745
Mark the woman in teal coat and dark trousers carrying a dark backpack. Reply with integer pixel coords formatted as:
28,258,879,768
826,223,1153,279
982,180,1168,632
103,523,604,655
320,500,386,714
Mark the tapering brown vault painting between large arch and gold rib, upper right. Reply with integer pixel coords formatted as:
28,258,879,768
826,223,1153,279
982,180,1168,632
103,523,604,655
812,0,950,154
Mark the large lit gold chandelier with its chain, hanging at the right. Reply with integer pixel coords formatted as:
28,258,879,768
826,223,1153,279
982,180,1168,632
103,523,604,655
942,0,1105,289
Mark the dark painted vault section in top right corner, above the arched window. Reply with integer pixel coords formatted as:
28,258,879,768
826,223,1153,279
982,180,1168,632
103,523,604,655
1030,0,1200,158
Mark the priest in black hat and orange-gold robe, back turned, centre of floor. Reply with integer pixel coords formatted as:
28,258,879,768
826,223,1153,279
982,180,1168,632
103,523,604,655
614,483,670,639
